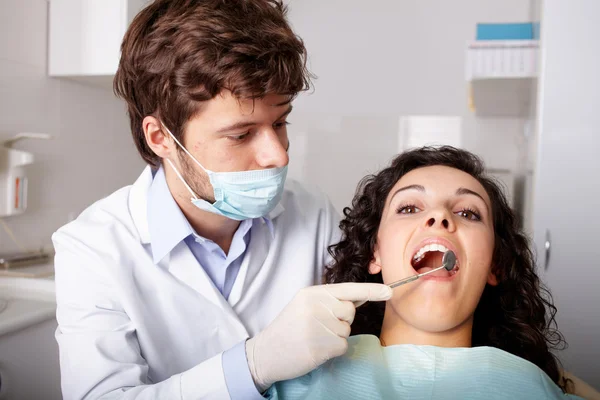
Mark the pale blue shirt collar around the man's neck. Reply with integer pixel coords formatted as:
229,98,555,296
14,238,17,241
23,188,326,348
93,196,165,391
148,166,284,263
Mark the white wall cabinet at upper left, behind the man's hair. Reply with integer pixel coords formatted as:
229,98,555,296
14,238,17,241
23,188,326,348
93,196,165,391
48,0,146,86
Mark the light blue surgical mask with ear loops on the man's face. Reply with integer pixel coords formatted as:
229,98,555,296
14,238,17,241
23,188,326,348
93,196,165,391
163,125,287,221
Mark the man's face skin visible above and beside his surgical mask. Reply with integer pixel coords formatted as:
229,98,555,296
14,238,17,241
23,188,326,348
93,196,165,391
167,91,292,203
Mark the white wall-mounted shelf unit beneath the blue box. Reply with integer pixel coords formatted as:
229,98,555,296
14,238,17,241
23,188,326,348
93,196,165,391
465,40,539,117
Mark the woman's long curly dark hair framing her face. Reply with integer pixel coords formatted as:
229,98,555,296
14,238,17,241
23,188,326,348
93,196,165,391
325,146,566,390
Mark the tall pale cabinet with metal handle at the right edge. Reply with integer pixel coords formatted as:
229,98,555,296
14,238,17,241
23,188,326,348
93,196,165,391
534,0,600,389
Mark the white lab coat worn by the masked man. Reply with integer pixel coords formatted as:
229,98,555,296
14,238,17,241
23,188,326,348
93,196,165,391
53,168,339,400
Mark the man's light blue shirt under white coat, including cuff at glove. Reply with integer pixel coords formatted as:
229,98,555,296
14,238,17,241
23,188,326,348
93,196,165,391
148,167,273,400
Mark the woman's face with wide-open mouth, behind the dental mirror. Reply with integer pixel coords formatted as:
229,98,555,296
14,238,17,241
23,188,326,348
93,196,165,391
370,166,496,340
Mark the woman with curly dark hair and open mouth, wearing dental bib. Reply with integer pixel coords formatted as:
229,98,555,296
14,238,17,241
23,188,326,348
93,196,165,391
269,147,591,399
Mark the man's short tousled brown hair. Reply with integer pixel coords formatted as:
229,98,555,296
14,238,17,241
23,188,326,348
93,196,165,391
114,0,311,166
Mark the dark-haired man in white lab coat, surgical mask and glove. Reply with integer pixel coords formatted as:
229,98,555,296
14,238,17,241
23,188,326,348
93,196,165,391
53,0,391,400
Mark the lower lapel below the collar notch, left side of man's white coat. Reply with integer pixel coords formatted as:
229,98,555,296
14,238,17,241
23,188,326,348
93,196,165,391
167,241,248,340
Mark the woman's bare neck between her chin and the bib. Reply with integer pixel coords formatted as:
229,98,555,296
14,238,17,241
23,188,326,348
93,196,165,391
379,307,473,347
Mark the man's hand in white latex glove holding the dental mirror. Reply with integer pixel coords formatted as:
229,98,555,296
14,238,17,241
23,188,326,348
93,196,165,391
246,283,392,393
